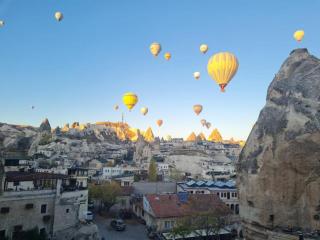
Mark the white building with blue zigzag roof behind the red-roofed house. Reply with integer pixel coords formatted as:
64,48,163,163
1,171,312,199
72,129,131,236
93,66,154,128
177,180,239,215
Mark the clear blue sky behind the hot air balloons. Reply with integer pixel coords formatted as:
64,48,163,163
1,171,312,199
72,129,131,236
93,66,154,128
0,0,320,139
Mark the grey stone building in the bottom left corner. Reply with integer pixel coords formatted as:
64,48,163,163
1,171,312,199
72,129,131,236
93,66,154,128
0,167,95,239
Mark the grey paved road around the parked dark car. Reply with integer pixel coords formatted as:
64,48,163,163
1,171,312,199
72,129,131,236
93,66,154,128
94,214,149,240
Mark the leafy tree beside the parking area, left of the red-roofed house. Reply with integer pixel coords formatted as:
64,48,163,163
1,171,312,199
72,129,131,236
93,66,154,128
89,182,121,211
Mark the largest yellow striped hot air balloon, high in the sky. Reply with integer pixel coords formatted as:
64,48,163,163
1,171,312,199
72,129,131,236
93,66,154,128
207,52,239,92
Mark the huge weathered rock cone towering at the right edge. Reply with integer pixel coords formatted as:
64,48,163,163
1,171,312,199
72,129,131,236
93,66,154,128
238,49,320,240
